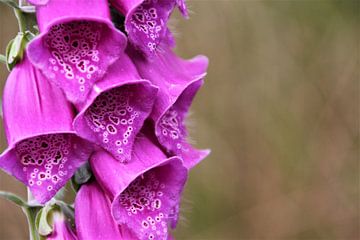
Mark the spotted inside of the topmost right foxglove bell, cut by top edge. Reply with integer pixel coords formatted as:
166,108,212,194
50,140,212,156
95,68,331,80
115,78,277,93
129,0,174,52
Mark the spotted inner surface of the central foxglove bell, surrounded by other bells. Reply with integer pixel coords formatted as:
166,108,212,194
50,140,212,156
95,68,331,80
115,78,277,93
85,85,146,162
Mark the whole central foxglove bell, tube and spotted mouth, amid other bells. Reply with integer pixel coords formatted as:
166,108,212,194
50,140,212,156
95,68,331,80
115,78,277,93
74,54,157,162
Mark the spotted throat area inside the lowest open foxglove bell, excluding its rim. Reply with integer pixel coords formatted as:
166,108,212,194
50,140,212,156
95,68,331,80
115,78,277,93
119,167,178,239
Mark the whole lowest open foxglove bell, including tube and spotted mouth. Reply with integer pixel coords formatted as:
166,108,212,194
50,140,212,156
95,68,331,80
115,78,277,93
90,136,187,239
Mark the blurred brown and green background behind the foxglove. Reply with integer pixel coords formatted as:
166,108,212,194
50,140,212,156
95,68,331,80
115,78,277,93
0,0,360,240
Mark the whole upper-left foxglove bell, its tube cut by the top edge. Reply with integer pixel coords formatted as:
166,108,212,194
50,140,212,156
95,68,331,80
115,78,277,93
27,0,126,103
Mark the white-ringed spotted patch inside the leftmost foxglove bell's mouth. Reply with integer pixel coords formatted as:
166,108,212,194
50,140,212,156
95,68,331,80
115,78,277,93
16,134,74,191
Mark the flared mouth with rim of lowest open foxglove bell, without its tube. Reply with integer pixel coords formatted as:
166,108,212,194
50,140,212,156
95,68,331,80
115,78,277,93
112,158,186,239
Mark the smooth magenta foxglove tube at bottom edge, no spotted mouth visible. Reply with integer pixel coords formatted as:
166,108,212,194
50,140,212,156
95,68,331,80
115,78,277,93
75,182,124,240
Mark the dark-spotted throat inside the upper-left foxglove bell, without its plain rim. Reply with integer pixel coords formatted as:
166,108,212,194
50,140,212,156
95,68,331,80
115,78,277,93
44,21,102,99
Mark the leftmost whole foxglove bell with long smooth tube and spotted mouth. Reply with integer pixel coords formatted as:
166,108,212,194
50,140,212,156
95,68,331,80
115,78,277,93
0,57,91,203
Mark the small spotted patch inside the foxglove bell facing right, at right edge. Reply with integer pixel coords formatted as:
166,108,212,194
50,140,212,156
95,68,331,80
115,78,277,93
159,106,186,153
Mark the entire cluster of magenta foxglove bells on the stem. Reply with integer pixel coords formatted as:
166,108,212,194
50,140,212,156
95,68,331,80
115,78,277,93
0,0,209,239
